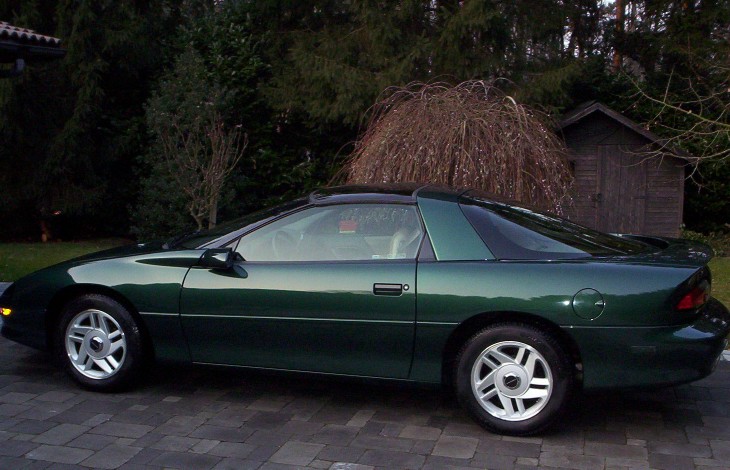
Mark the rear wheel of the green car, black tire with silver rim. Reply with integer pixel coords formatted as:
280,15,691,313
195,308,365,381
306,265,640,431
455,323,573,436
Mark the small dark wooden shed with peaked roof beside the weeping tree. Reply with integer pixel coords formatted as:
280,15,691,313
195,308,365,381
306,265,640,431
558,102,687,237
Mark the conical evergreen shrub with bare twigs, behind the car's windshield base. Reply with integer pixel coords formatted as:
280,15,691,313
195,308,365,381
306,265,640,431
138,46,245,235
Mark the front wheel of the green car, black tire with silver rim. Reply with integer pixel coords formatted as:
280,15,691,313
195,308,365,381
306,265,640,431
55,294,144,392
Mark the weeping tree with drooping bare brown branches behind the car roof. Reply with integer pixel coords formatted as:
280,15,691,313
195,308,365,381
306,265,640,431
342,81,572,213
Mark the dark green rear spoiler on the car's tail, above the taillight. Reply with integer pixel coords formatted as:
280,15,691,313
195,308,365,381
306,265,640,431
621,235,715,268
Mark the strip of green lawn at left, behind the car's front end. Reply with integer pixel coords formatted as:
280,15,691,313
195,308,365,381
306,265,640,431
0,238,130,281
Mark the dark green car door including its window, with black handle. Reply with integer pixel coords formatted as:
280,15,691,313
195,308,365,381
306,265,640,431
181,204,423,378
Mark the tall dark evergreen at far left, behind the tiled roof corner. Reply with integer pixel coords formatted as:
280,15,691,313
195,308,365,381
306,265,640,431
0,0,182,241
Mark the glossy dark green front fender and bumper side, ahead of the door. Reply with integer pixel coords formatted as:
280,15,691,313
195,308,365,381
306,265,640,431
0,250,202,360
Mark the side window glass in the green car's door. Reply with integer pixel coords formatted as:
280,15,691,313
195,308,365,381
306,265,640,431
236,204,423,261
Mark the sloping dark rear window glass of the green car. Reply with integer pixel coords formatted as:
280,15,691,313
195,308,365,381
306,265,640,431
460,192,650,259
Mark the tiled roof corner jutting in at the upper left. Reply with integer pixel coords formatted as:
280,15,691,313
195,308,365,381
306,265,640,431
0,21,66,63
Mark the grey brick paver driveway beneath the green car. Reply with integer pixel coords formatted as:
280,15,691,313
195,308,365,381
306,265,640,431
0,332,730,470
